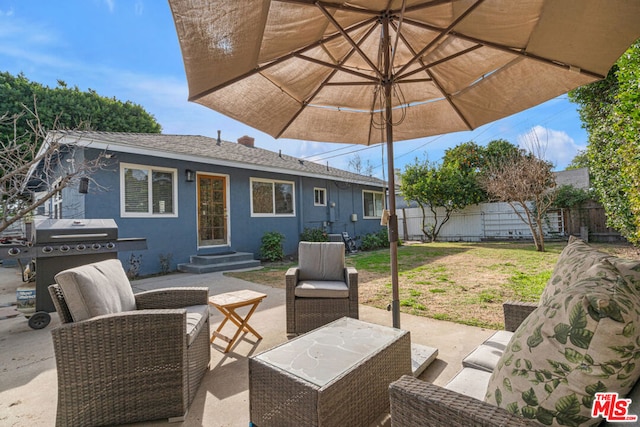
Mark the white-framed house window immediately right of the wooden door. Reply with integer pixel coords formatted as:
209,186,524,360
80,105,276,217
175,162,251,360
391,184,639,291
251,178,295,216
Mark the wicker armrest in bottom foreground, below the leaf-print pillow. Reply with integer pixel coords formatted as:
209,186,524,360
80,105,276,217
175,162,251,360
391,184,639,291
389,375,540,427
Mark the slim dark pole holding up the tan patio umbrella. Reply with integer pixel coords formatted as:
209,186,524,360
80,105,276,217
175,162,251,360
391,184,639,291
382,14,400,329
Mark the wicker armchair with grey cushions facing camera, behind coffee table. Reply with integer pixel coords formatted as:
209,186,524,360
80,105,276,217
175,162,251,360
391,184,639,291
285,242,358,335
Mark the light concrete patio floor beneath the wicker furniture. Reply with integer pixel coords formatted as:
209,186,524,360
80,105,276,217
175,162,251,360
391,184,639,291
0,266,493,427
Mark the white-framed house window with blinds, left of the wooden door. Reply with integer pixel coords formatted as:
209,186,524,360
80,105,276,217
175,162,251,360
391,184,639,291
120,163,178,217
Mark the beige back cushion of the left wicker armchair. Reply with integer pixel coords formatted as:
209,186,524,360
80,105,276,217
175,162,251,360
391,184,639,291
55,259,136,322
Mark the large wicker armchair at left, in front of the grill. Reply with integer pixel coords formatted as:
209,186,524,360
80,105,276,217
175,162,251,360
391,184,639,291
49,260,211,426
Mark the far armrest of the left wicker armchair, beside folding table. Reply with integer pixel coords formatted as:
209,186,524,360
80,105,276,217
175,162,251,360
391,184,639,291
135,287,209,310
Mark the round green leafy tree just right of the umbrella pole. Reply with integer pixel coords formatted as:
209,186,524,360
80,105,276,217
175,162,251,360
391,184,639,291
400,159,485,242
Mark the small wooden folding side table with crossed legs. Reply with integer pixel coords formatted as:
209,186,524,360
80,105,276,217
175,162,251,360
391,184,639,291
209,289,267,353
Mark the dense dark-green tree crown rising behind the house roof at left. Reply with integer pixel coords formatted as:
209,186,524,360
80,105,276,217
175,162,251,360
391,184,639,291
0,72,162,147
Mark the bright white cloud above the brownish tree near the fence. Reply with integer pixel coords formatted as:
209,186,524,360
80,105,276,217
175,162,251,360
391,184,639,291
517,125,586,170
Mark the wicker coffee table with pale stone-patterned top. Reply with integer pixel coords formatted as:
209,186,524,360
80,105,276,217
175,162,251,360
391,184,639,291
249,317,411,427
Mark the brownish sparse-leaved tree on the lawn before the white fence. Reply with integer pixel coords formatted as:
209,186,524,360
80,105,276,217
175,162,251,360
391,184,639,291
481,134,555,252
